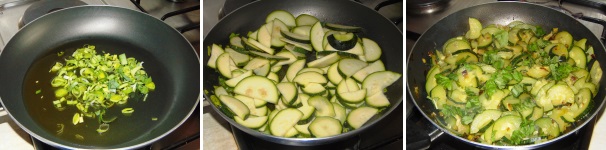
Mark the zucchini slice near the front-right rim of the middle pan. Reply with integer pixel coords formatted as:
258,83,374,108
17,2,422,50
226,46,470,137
347,106,379,129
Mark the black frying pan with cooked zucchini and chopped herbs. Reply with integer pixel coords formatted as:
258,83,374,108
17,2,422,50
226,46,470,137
406,2,606,149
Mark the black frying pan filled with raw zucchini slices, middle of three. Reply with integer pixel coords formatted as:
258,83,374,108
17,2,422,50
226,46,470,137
203,0,403,146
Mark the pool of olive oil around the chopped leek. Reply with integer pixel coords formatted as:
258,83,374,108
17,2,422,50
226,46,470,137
22,45,170,146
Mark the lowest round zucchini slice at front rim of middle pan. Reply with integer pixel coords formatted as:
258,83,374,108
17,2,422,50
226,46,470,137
309,117,343,138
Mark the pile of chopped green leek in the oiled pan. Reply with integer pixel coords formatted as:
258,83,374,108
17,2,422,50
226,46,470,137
49,45,156,132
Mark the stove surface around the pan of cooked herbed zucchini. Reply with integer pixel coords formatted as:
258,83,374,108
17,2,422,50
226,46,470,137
406,0,606,150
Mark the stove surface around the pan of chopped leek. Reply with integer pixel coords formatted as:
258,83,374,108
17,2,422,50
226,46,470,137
0,0,200,149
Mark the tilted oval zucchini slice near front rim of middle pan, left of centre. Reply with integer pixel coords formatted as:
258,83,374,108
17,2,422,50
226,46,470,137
269,108,303,137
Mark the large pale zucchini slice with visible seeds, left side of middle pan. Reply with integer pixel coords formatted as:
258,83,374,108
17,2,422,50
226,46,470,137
234,76,280,104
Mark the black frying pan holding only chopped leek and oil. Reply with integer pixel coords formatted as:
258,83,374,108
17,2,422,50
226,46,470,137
0,6,200,149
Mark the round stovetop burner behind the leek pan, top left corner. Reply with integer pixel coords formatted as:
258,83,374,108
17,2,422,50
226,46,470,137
18,0,86,29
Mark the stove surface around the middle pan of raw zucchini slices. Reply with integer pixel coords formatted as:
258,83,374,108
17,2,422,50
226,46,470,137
203,0,404,150
